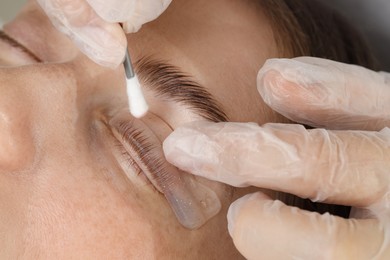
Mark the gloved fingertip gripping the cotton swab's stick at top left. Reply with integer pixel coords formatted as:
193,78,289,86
38,0,127,68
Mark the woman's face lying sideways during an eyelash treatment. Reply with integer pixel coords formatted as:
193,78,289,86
0,0,281,259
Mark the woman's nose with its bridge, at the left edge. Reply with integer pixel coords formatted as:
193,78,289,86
0,58,125,172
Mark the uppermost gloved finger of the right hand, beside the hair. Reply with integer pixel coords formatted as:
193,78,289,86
257,57,390,130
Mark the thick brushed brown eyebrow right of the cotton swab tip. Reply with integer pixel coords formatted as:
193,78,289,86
135,57,228,122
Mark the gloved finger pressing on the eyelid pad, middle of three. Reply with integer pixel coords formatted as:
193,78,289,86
163,122,390,207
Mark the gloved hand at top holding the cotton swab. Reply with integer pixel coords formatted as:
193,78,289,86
37,0,171,68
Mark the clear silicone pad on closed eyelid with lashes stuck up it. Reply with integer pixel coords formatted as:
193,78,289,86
109,112,221,229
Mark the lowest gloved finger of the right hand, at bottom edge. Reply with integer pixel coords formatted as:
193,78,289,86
228,193,390,259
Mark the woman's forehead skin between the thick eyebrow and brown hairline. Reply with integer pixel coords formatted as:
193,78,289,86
128,0,278,123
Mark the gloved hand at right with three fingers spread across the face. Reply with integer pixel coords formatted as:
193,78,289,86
164,58,390,259
